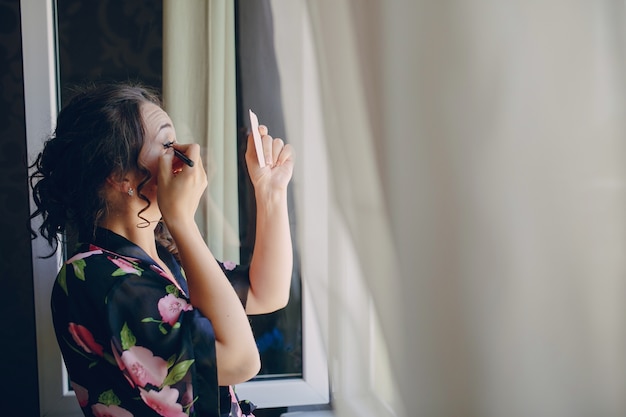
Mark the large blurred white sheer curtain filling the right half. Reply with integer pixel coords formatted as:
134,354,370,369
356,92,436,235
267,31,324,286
307,0,626,417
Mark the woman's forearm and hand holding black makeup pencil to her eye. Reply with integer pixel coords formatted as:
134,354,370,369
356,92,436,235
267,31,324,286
157,144,261,385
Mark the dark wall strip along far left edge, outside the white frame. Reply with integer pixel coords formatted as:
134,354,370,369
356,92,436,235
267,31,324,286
0,0,39,416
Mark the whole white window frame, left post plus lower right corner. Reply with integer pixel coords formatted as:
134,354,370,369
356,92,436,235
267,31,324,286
20,0,329,417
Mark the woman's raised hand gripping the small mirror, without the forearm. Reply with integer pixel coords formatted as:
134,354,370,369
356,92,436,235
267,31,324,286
246,125,295,193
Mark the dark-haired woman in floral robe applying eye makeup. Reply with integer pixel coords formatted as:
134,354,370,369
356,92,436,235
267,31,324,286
31,85,293,417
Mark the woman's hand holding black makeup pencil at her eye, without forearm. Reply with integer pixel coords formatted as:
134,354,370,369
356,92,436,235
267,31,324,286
157,143,208,231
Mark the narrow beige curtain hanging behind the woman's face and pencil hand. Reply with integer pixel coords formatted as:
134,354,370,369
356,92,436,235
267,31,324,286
163,0,239,262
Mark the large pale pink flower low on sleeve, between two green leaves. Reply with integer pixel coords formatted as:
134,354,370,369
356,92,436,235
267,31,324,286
120,346,167,387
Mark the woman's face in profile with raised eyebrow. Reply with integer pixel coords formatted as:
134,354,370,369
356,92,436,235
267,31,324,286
139,102,176,200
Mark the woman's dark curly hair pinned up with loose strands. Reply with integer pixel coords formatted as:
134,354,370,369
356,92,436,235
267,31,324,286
30,84,160,253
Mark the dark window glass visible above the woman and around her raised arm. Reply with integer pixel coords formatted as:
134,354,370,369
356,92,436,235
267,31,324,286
56,0,303,379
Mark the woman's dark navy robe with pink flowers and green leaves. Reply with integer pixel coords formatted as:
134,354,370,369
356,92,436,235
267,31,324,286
51,229,252,417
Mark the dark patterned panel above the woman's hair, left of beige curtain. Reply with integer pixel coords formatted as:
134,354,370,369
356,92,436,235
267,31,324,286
57,0,163,102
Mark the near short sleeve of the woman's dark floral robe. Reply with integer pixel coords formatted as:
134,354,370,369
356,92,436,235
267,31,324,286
107,271,219,415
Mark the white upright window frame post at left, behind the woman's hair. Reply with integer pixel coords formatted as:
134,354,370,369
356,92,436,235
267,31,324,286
20,0,82,417
